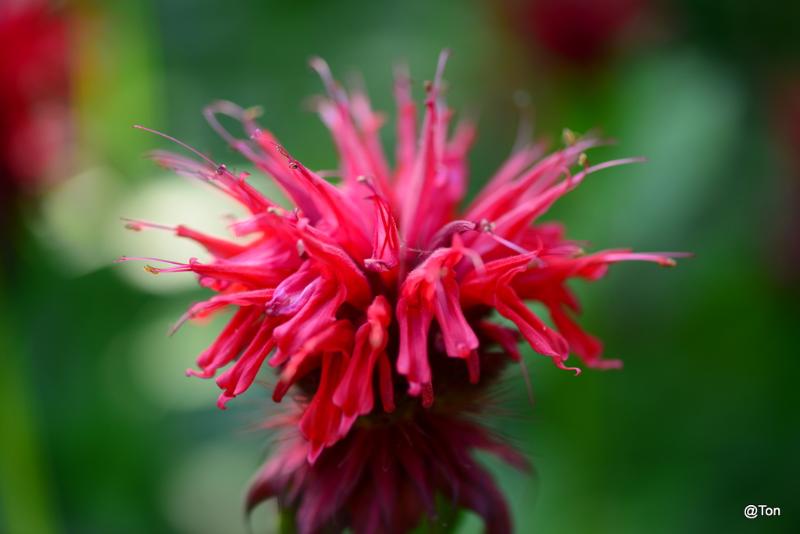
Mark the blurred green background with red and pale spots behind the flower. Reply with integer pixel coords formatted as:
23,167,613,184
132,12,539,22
0,0,800,534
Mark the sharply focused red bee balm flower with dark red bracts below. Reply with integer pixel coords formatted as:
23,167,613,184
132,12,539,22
130,54,674,532
